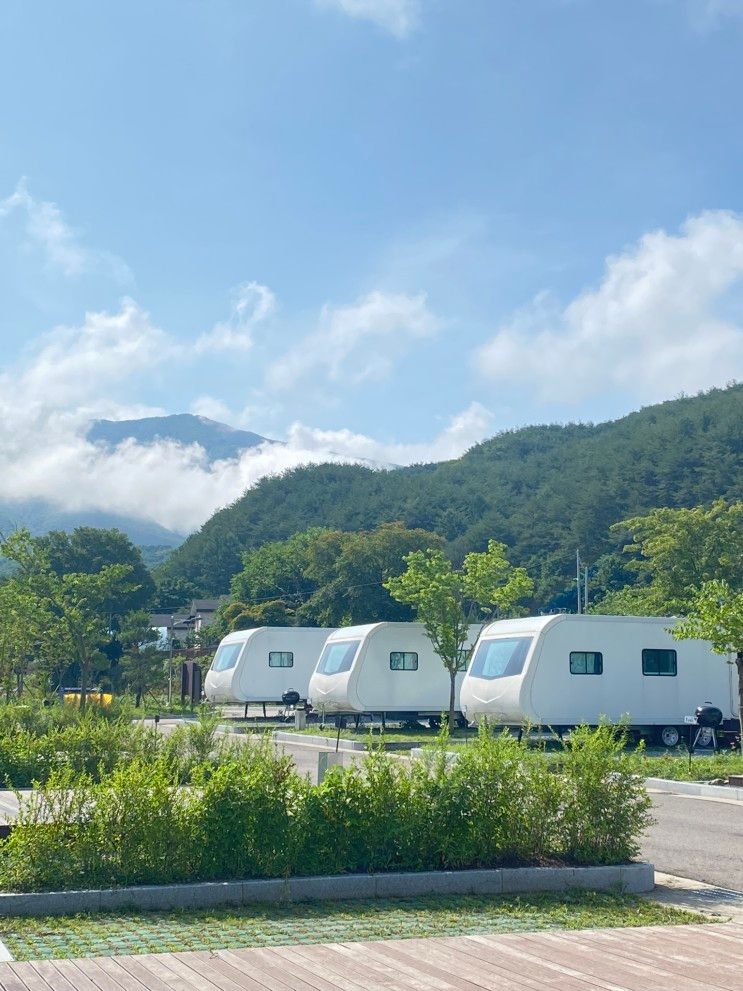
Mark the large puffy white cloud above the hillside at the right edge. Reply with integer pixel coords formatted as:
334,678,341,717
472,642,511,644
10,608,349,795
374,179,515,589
475,211,743,402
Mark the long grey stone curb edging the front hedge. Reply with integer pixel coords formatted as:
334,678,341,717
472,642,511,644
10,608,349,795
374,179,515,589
0,863,654,917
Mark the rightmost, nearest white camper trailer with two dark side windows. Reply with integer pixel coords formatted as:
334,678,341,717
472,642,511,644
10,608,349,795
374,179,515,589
461,615,738,747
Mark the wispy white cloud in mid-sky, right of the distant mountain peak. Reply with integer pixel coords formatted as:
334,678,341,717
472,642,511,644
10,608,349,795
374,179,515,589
267,290,441,390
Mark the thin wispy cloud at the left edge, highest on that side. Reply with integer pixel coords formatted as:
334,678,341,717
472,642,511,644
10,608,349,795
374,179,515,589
0,179,132,283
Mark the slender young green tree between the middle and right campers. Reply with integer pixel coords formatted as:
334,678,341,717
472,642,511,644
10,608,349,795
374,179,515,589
385,540,534,729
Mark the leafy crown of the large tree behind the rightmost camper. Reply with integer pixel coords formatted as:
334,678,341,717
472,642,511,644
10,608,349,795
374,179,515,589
595,499,743,616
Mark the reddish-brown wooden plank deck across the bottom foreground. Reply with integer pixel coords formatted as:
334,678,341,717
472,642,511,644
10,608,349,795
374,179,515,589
0,924,743,991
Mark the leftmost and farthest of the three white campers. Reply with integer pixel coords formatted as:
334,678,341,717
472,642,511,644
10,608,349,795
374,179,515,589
204,626,333,704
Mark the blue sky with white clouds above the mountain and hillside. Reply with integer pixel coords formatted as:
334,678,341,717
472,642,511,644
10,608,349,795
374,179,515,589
0,0,743,526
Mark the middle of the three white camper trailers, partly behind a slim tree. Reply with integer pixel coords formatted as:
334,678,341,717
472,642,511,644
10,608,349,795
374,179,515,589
310,623,480,723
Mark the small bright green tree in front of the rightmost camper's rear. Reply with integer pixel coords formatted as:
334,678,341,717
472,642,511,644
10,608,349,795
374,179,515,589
671,580,743,753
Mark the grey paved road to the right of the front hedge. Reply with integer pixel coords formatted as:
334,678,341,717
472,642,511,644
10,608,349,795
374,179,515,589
642,794,743,891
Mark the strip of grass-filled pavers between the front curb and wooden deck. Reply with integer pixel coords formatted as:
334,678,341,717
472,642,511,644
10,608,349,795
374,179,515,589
0,891,707,960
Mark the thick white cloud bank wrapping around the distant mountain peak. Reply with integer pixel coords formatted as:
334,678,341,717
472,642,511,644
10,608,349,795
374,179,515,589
0,292,490,532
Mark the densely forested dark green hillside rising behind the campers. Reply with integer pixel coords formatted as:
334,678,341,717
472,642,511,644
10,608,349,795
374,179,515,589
161,385,743,608
